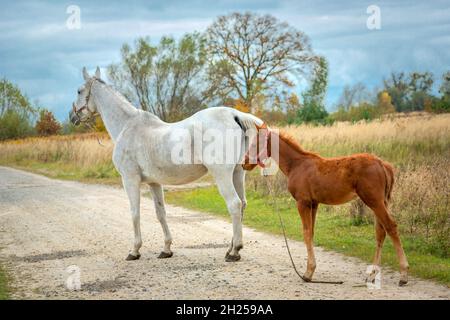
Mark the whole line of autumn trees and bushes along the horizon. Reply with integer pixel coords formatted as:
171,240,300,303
0,12,450,139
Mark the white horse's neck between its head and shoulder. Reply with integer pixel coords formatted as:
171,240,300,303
92,82,138,142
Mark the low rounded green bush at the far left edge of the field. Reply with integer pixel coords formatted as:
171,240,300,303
0,109,34,140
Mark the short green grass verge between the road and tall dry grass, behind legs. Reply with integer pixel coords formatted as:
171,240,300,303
166,187,450,286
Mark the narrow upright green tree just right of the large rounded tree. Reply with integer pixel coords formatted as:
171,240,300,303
297,57,328,123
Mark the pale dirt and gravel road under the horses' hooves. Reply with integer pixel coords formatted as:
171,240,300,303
0,167,450,299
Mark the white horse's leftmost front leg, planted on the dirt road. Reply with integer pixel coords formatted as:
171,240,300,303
122,176,142,260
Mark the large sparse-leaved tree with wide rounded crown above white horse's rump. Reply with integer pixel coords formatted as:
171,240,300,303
206,13,317,112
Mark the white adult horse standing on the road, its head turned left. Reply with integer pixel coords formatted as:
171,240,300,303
70,67,263,261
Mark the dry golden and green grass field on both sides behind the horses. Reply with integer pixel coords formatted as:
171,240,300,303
0,114,450,285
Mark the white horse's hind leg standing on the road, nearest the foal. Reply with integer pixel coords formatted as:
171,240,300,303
213,168,243,262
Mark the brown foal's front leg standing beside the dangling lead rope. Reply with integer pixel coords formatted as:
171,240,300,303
297,200,317,281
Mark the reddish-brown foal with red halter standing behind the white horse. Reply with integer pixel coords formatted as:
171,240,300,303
243,124,408,286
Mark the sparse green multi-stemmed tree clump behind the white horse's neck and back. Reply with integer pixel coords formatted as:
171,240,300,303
108,33,206,121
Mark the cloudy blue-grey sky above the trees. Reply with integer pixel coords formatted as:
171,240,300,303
0,0,450,120
